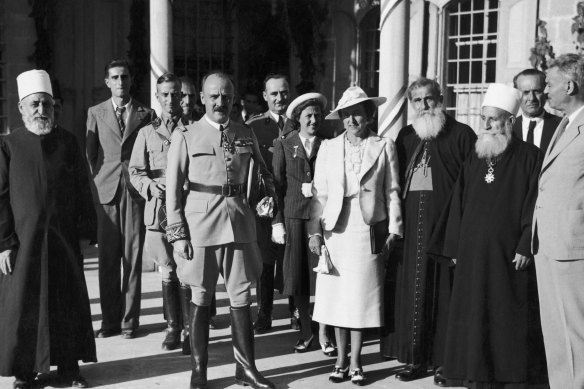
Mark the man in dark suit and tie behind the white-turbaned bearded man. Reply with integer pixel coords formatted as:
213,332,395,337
513,69,561,154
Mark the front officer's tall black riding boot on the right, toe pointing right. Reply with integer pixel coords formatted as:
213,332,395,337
229,305,275,389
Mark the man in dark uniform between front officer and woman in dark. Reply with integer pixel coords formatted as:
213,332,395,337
246,74,297,334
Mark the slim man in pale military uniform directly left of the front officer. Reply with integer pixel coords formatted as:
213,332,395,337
130,73,191,354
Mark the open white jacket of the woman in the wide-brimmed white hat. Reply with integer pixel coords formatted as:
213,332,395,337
308,132,403,236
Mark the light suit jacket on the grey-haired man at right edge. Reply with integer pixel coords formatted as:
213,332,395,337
532,107,584,261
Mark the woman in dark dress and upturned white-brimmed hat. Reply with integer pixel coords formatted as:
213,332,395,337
272,93,336,356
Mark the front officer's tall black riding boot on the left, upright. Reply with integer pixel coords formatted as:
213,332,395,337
190,303,209,389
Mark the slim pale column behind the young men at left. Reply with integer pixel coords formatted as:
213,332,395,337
150,0,174,115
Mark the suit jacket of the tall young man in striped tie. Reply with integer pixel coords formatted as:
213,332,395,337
86,99,156,204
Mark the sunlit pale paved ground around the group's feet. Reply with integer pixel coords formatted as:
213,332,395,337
0,244,460,389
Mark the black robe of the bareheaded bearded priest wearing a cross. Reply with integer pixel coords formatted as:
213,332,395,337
381,115,476,365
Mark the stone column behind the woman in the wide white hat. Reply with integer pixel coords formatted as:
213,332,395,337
378,0,410,139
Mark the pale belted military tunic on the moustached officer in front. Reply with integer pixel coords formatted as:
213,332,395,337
166,117,274,247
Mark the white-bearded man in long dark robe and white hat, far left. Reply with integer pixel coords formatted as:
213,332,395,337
0,70,96,388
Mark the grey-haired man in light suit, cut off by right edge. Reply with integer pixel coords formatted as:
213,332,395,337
532,54,584,389
